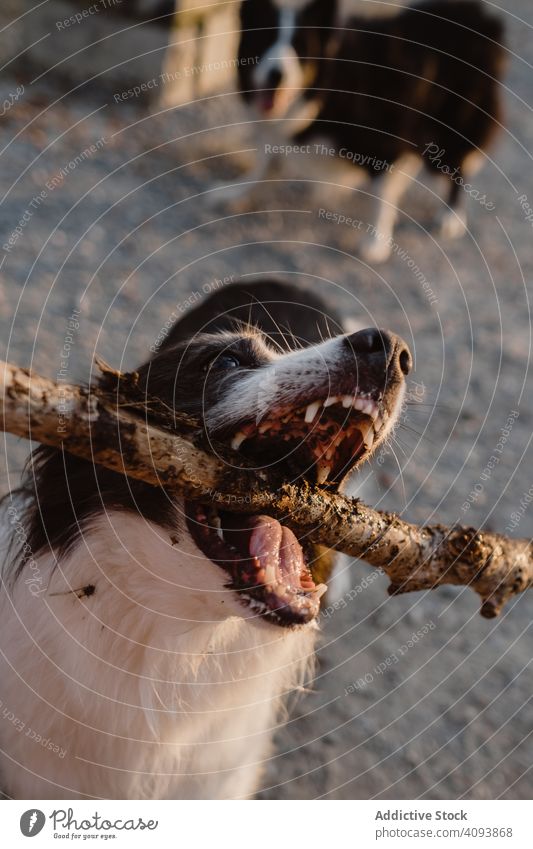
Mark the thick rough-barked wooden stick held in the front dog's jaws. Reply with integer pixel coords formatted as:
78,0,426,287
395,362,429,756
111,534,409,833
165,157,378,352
0,362,533,618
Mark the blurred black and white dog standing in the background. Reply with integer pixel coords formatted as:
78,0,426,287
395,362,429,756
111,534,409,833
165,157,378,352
213,0,504,261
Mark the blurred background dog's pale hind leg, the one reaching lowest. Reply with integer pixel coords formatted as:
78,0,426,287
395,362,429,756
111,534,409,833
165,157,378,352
360,153,422,262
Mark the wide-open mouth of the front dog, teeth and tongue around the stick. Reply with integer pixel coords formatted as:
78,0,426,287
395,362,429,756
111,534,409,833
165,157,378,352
186,394,387,625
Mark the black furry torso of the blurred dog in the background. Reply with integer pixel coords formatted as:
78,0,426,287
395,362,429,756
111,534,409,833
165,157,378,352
297,0,504,173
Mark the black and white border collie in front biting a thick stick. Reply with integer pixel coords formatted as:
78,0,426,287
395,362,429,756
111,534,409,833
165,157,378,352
0,281,411,799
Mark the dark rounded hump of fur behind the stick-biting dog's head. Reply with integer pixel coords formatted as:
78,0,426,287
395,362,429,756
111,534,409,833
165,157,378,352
156,280,345,351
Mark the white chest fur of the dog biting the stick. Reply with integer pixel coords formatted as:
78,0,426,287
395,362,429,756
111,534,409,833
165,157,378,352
0,506,317,799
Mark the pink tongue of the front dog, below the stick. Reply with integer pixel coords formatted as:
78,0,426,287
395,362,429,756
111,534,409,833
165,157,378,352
220,514,305,589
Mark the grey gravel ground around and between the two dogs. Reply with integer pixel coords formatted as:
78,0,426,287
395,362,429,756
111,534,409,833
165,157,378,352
0,0,533,799
